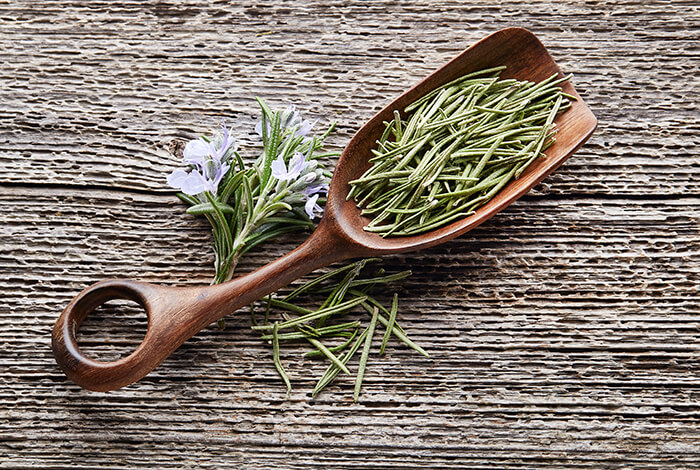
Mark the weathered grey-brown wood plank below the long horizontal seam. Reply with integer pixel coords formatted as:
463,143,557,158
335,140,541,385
0,188,700,468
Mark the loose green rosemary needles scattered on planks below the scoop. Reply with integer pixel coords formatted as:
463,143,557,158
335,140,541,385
251,258,428,401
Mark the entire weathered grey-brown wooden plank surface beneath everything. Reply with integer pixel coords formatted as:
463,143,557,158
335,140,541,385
0,0,700,469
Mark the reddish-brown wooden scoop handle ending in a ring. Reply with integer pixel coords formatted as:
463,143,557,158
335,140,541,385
52,223,362,391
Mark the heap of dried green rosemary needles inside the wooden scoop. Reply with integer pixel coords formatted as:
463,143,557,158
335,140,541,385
348,66,576,237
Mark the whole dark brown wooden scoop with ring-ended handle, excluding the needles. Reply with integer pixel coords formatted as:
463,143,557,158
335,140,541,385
52,28,597,391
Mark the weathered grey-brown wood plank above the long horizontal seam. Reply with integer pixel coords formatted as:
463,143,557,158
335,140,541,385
0,2,700,195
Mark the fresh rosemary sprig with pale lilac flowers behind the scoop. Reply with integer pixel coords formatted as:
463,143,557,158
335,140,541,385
168,98,338,284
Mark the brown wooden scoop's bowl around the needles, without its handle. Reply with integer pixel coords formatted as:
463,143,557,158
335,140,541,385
326,28,598,256
